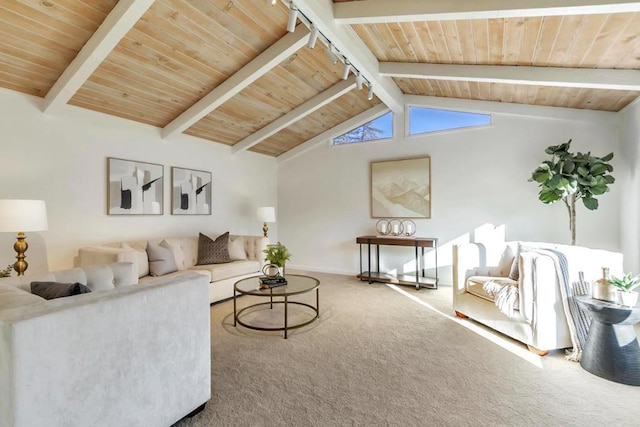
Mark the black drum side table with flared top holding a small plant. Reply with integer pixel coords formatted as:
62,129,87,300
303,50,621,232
576,295,640,385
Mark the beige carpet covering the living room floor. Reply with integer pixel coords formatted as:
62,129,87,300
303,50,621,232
176,273,640,427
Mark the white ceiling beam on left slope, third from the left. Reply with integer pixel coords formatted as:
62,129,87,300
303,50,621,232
231,76,356,153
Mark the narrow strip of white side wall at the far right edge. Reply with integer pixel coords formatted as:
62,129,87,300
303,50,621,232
618,102,640,274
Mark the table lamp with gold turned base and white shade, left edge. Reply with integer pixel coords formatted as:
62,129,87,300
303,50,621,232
0,200,48,276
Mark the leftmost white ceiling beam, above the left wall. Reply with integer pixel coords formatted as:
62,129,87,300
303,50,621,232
43,0,154,113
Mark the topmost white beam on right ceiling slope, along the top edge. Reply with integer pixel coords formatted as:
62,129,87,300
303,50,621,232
332,0,640,24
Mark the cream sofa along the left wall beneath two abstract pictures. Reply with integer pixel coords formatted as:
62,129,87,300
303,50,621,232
75,234,269,303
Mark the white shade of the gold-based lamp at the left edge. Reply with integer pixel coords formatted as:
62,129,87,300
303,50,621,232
0,199,48,232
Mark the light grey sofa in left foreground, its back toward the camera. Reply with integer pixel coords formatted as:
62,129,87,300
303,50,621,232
0,263,211,427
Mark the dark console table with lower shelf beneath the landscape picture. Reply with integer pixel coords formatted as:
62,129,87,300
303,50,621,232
356,236,438,289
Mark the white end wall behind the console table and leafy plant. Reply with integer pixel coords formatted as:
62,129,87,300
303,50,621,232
278,104,621,283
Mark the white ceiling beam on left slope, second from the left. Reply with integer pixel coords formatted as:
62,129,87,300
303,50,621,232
162,24,309,138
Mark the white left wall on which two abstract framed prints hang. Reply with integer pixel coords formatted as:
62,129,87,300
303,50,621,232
0,90,277,274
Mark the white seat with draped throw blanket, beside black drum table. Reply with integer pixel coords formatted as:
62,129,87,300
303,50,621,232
453,242,623,355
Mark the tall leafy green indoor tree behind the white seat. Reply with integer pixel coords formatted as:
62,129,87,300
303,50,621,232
529,140,615,245
